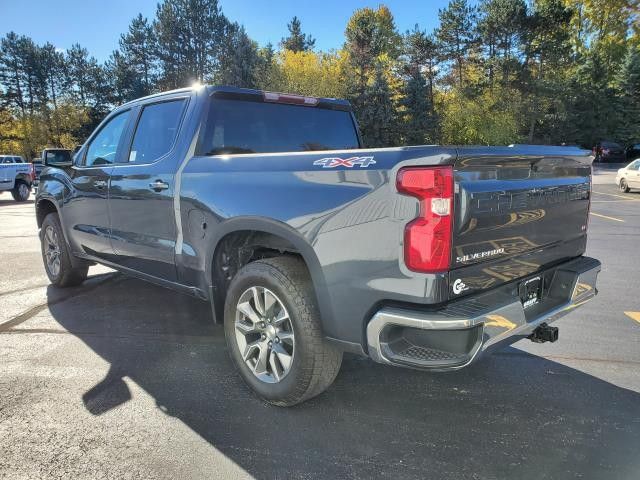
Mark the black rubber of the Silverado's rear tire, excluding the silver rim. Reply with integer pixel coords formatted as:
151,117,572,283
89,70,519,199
224,256,342,407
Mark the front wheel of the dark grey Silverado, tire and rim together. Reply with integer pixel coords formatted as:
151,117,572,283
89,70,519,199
40,213,89,287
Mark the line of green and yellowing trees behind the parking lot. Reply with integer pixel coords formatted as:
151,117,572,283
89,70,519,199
0,0,640,157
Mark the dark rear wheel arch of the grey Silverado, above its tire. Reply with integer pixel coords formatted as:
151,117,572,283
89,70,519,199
206,217,332,330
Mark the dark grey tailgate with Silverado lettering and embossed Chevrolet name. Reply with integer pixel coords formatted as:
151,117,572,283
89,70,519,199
449,147,592,298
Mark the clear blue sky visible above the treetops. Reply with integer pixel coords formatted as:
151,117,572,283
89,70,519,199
0,0,456,61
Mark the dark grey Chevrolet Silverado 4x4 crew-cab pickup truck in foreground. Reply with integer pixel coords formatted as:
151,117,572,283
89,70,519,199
36,87,600,406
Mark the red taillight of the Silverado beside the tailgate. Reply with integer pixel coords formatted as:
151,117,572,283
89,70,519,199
396,167,453,273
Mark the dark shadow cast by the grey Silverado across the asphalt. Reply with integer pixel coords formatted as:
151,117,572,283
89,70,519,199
49,275,640,479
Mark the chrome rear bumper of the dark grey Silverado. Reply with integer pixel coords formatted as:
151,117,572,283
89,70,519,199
367,257,601,370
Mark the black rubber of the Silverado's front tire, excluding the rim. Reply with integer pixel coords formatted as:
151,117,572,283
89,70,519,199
40,213,89,288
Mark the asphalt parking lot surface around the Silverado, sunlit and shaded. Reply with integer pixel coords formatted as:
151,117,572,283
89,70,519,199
0,173,640,480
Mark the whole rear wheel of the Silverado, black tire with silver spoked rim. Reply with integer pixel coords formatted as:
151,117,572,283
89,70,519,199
224,257,342,406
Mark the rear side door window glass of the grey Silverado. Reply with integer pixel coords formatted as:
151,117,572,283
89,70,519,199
129,99,186,163
